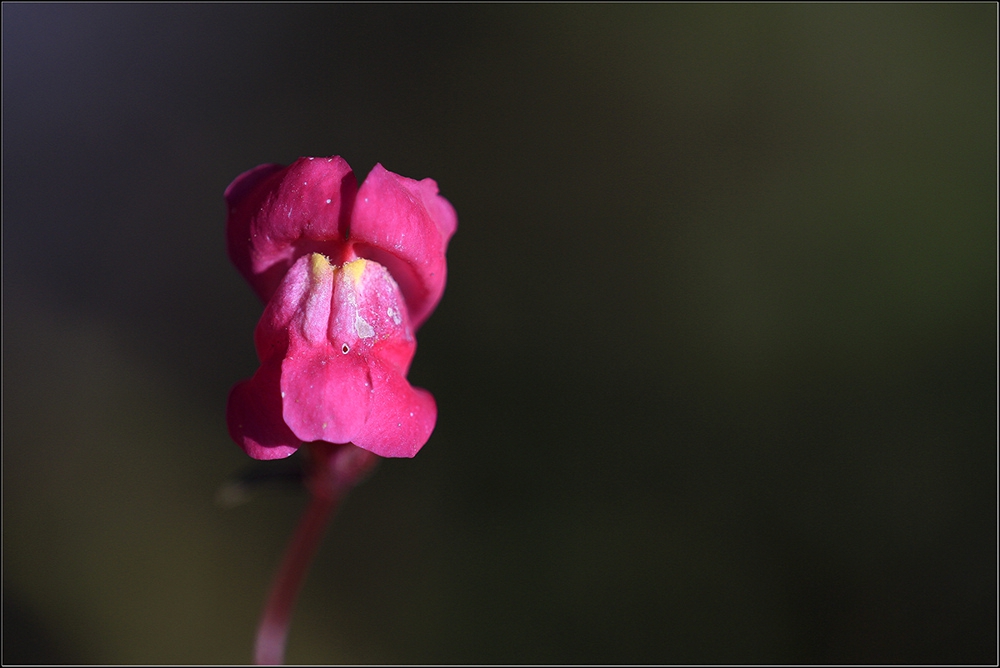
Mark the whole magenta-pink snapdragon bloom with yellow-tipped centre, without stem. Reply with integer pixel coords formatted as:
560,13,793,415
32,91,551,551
226,157,456,459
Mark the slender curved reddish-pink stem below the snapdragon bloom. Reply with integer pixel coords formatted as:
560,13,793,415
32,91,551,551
254,493,341,665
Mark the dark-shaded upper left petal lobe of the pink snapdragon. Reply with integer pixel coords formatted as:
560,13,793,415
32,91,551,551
226,156,357,302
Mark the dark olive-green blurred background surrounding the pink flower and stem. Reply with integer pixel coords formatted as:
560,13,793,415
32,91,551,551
2,3,997,664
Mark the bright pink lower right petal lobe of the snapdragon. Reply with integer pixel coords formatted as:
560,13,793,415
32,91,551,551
353,360,437,457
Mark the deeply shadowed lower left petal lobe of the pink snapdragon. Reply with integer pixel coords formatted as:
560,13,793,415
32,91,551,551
226,364,302,459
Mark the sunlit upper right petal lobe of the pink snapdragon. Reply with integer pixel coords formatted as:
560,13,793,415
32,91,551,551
350,165,457,329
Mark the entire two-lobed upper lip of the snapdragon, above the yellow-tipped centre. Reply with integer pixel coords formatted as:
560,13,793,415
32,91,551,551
225,156,457,328
